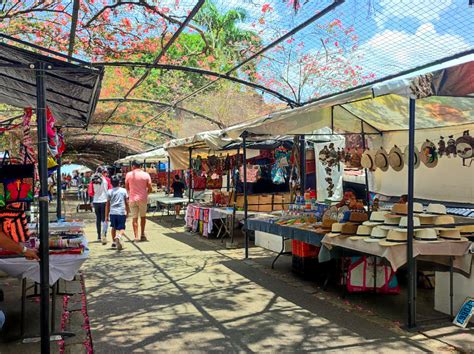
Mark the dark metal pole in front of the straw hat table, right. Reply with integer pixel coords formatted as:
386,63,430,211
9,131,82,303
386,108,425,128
407,98,416,328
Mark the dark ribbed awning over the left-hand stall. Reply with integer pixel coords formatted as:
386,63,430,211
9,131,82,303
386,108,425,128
0,43,103,127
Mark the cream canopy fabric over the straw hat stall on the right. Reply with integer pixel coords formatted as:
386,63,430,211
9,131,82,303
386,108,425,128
224,55,474,138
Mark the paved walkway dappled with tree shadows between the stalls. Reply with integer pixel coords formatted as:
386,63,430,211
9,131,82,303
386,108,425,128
84,217,449,353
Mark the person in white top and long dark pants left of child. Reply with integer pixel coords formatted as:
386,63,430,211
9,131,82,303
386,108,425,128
89,166,112,245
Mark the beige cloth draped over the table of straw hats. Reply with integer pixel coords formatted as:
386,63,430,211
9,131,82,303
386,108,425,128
319,236,472,274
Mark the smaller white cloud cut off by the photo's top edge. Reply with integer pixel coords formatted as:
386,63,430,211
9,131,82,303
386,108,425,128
375,0,453,27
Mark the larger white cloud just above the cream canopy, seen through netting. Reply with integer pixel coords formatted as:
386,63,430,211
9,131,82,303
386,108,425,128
359,23,472,77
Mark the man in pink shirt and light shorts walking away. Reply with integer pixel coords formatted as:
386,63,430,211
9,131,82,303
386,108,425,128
125,161,152,241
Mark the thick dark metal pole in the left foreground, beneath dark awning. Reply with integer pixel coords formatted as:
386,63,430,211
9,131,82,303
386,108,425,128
35,62,50,353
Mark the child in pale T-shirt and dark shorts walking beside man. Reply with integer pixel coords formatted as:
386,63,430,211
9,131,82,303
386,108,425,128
105,176,130,251
